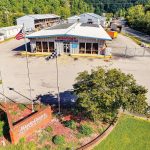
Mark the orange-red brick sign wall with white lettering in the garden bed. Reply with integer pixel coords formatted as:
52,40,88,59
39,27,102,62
9,107,52,144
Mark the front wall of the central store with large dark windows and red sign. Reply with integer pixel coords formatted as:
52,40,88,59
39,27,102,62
30,36,105,55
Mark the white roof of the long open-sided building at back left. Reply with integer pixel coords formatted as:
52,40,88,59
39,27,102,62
18,14,60,20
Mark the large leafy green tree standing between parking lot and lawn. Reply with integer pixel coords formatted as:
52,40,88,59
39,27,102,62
73,68,147,121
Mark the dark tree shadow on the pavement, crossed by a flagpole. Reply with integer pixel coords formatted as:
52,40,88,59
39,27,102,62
37,90,76,108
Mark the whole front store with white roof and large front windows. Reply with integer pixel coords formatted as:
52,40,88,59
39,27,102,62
26,23,111,55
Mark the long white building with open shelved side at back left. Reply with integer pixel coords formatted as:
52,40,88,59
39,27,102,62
17,14,60,31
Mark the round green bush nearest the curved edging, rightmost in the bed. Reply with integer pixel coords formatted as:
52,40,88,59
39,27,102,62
79,125,93,136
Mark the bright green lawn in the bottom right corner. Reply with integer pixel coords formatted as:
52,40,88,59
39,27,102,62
94,115,150,150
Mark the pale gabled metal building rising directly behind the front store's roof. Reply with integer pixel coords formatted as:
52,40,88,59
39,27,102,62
67,13,107,27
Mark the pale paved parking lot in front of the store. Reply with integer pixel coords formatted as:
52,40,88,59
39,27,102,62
0,35,150,103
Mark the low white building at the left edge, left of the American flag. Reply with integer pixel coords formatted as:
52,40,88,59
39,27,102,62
0,26,22,39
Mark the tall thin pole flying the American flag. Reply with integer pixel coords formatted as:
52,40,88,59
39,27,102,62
23,24,34,112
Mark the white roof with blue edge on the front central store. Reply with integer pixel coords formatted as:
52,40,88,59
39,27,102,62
26,23,111,40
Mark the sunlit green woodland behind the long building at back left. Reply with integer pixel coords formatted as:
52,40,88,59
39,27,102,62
0,0,93,26
